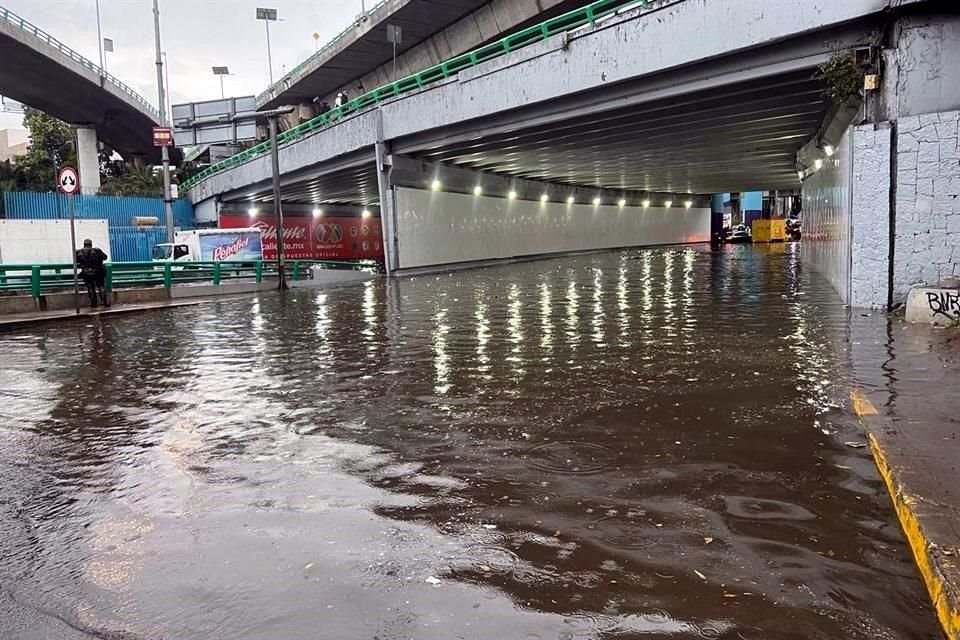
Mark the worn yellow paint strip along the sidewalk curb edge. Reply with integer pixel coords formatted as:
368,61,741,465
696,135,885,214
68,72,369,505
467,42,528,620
850,391,960,640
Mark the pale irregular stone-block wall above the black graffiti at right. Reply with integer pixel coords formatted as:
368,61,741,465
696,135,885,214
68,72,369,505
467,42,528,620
893,110,960,303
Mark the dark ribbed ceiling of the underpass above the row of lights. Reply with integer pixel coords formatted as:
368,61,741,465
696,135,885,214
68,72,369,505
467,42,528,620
413,71,829,193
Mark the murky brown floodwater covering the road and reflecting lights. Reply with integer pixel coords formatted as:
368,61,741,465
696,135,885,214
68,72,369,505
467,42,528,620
0,245,940,640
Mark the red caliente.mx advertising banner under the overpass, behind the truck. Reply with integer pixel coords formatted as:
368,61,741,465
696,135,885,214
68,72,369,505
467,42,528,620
220,214,383,260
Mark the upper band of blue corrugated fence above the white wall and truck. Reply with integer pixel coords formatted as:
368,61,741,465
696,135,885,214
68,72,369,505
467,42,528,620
3,191,196,229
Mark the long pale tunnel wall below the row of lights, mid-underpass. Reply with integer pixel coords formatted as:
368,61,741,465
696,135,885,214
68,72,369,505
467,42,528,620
396,188,710,269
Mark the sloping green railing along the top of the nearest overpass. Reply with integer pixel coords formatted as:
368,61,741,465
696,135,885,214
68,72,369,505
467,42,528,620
180,0,648,189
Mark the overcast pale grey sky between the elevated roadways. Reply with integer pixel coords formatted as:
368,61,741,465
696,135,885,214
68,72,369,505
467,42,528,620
0,0,366,129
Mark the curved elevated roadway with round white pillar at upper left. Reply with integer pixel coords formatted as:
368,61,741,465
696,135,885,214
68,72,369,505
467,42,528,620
0,7,160,185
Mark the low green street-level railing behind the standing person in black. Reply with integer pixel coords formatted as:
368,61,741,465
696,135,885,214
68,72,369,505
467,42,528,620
0,260,379,298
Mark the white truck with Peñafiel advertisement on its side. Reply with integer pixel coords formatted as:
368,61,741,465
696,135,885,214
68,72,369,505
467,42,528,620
152,227,263,263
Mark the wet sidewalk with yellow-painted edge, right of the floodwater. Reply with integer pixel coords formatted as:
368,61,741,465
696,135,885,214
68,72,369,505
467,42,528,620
851,321,960,640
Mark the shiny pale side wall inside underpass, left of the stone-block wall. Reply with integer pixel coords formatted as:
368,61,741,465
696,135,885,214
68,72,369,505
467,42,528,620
801,131,852,302
